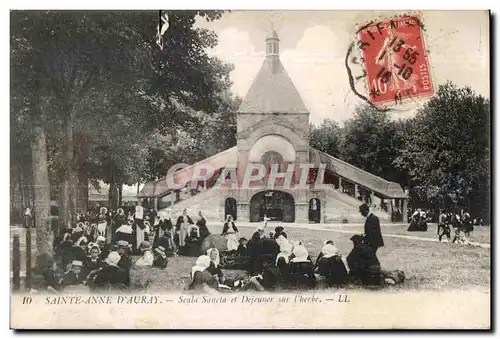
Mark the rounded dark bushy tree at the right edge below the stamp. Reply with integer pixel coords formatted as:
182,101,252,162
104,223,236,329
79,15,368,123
395,82,490,218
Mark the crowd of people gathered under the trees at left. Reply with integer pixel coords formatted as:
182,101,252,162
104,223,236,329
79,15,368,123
43,206,210,293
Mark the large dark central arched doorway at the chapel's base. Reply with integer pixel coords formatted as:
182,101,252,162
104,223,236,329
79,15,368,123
250,190,295,222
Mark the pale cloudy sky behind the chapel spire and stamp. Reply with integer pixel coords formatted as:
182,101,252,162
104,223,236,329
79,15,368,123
198,11,490,124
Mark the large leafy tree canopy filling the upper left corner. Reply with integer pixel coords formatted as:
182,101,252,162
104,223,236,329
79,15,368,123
11,11,230,256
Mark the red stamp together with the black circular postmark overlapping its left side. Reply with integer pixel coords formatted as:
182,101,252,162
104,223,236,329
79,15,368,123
345,14,434,110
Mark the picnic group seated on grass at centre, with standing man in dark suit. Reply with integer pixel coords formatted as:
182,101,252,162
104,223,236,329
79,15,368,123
189,204,404,293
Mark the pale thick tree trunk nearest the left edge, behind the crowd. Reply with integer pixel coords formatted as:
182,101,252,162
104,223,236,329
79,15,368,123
31,127,54,257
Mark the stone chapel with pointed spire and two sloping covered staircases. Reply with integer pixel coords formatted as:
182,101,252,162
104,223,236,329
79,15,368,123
139,30,407,223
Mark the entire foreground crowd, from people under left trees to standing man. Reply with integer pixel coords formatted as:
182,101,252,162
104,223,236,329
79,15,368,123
36,204,404,293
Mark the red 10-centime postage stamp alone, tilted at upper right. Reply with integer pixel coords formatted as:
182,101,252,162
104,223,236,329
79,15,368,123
358,16,434,105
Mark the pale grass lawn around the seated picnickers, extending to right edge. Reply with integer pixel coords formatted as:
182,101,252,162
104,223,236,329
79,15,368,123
137,226,491,292
